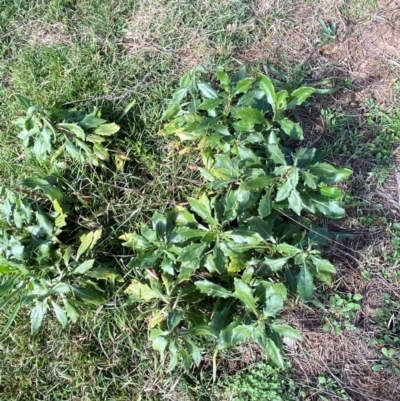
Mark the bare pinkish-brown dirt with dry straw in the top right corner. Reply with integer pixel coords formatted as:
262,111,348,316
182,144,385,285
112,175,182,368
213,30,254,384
236,0,400,106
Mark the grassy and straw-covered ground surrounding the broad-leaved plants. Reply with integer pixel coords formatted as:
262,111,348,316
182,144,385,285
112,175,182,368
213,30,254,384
0,0,400,401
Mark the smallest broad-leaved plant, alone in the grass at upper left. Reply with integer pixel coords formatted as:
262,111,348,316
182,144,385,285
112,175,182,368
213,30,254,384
14,96,120,166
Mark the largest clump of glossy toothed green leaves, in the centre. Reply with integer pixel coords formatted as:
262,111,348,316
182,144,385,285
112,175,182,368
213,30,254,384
121,69,351,371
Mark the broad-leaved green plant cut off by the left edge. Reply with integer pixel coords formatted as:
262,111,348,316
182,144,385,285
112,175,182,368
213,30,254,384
0,176,120,334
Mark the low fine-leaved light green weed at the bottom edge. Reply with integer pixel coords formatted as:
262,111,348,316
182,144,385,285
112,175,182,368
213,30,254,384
216,363,299,401
